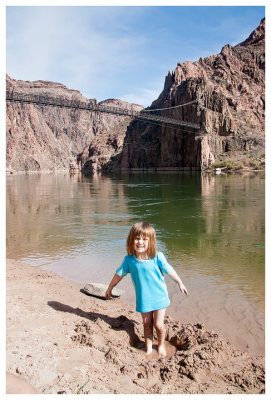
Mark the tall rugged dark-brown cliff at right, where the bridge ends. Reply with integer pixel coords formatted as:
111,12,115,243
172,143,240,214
118,19,265,169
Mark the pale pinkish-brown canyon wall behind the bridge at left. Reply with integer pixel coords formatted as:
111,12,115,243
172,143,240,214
6,76,143,173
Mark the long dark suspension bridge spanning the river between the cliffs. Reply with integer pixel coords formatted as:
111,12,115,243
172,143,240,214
6,91,201,132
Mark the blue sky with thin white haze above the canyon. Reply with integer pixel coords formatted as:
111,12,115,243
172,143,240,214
6,6,265,106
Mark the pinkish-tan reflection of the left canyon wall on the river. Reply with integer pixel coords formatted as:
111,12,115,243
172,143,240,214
7,174,132,258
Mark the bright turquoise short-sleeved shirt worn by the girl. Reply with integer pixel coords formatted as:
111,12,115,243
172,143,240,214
116,252,173,313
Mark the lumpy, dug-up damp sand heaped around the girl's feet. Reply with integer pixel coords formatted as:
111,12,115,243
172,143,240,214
69,315,265,393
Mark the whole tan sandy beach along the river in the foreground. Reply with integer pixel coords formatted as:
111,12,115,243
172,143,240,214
6,260,265,394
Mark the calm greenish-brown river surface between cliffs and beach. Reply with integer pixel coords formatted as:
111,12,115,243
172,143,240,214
7,173,265,353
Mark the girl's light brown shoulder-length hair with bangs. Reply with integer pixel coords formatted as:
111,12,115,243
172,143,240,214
126,222,156,258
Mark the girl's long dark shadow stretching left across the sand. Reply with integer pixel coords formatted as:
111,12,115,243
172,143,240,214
47,301,144,348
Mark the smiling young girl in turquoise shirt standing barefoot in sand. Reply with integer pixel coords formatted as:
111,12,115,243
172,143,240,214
105,222,188,357
